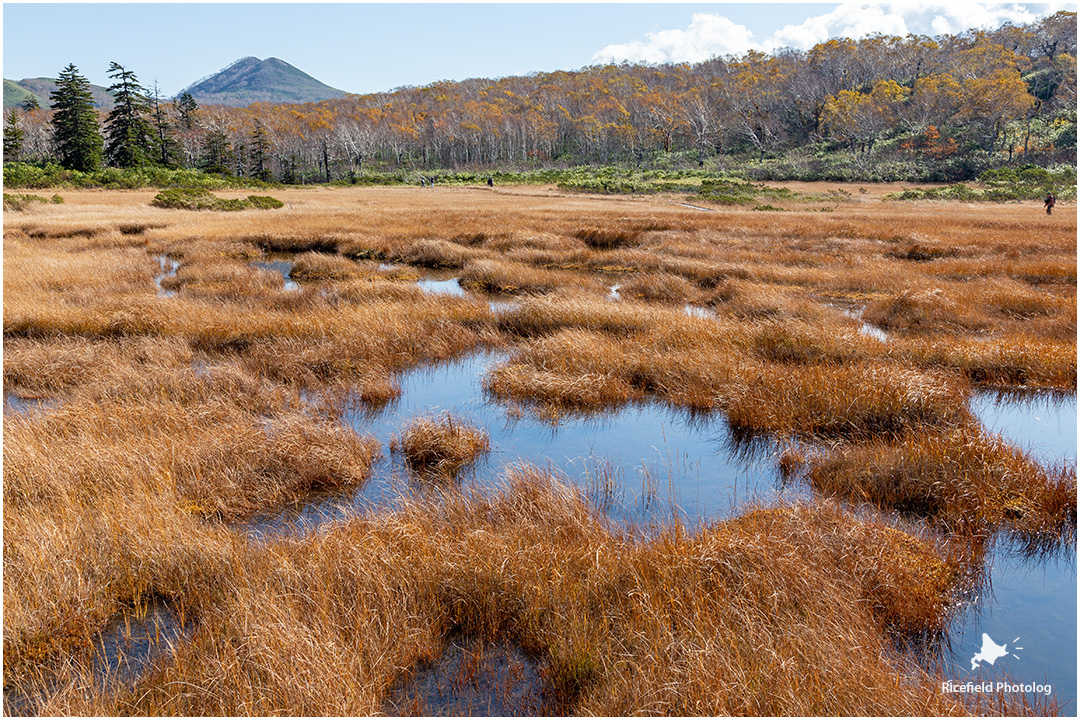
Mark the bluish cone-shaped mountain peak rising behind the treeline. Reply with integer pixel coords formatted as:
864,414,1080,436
178,57,348,107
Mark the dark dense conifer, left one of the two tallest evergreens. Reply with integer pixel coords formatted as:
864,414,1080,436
49,64,102,173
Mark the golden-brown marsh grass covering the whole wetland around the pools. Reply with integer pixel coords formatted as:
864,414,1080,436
3,181,1077,716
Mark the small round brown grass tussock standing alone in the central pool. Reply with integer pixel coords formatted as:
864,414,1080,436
390,413,490,477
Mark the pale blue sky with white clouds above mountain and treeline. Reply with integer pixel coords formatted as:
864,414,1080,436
3,2,1076,96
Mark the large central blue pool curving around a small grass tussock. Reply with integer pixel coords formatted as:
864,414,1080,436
248,355,806,537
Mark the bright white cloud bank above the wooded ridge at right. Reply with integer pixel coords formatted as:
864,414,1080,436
593,2,1076,63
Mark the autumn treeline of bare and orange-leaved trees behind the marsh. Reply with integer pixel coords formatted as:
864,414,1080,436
4,12,1077,182
